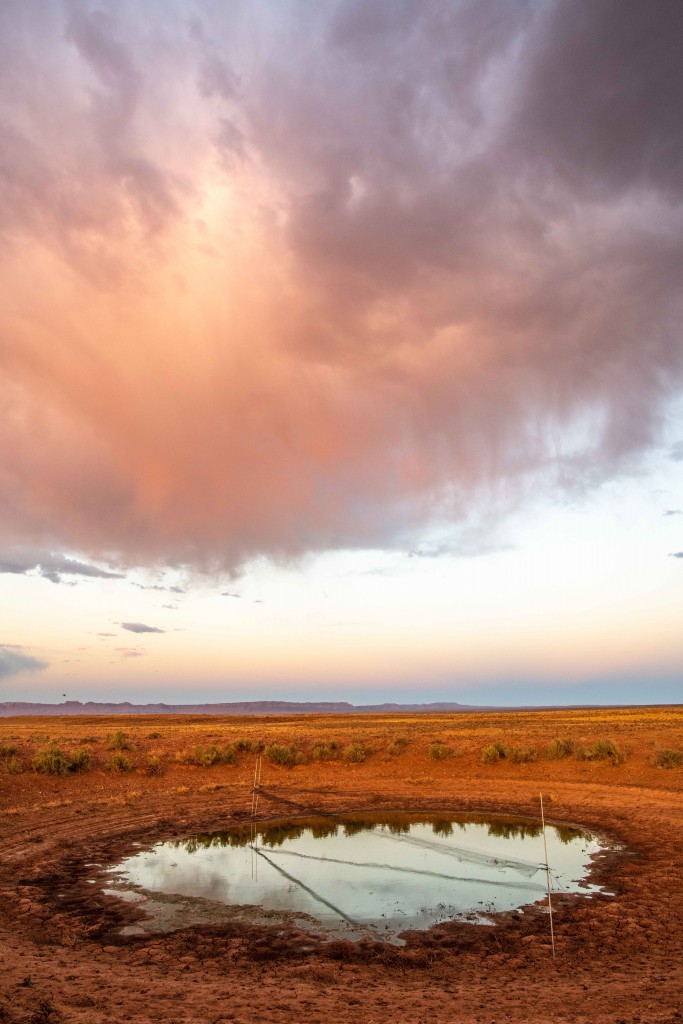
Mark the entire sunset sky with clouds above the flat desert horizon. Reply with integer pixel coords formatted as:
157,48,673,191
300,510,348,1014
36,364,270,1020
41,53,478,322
0,0,683,706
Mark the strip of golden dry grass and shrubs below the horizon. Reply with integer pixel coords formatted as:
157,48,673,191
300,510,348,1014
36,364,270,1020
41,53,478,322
0,707,683,805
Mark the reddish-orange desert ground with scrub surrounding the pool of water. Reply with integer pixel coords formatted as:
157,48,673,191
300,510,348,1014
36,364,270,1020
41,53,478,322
0,707,683,1024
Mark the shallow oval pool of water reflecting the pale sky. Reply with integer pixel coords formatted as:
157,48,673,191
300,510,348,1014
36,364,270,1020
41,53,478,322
104,813,606,942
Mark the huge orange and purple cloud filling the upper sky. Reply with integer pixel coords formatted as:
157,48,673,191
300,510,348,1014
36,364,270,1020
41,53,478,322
0,0,683,581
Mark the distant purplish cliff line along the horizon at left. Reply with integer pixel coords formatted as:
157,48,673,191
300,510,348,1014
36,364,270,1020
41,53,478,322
0,700,475,718
